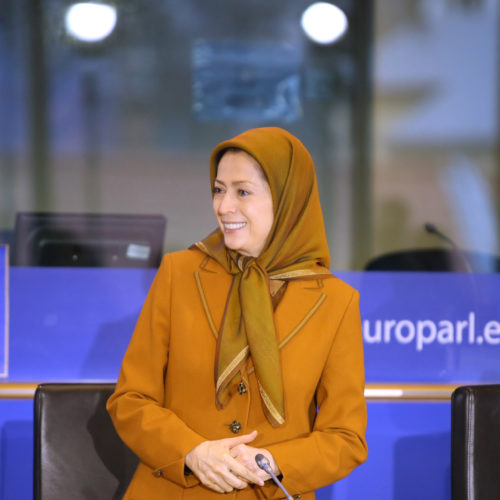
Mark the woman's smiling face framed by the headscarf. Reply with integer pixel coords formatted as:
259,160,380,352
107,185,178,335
213,150,274,257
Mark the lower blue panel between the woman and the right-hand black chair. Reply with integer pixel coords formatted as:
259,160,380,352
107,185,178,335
317,402,451,500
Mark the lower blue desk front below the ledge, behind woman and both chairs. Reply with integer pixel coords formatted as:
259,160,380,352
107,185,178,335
0,400,450,500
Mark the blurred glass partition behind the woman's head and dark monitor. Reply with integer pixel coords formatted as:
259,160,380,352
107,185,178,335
0,0,373,268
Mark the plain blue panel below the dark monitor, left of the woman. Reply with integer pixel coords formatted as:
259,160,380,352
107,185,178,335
9,267,155,382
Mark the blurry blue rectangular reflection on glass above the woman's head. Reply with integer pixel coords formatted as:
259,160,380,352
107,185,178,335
193,41,302,123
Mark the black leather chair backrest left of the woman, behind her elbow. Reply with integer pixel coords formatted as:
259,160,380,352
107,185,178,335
34,384,137,500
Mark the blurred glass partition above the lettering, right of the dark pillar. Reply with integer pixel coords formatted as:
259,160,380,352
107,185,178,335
372,0,500,271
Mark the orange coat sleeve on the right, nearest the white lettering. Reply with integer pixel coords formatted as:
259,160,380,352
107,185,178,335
266,291,367,498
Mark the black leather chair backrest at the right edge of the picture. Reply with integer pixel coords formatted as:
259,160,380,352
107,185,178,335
451,385,500,500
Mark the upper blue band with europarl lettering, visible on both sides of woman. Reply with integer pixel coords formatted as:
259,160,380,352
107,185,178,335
7,267,500,383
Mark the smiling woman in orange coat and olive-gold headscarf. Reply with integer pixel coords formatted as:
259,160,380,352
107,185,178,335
108,127,367,500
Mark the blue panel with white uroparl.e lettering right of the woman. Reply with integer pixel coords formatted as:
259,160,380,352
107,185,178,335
338,272,500,383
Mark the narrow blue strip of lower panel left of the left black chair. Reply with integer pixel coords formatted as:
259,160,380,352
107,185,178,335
0,400,33,500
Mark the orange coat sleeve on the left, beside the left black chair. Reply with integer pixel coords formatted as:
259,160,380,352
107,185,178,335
107,255,206,487
